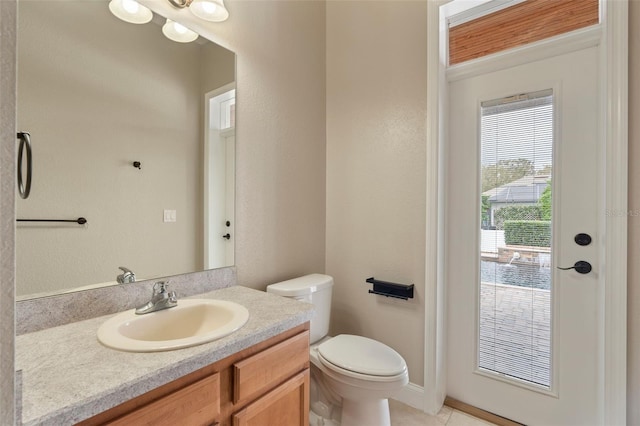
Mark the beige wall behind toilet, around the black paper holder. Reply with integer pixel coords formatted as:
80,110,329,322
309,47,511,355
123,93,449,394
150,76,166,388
326,1,427,385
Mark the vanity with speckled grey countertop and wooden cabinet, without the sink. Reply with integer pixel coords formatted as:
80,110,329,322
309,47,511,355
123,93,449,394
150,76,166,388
16,286,313,425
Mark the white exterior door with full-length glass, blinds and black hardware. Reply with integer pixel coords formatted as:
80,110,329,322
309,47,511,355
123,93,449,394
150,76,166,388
445,47,604,425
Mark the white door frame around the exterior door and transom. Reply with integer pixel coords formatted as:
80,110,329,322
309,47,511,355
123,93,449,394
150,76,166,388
424,0,629,424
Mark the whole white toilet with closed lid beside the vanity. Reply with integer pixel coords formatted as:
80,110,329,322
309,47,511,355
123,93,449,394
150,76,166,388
267,274,409,426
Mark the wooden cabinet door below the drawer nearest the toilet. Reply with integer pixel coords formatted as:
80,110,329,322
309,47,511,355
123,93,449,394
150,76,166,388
232,368,309,426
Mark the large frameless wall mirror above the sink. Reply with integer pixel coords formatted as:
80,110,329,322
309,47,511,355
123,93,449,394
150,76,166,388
16,0,235,299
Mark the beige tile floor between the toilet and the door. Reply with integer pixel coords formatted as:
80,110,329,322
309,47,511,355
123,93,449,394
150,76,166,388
389,399,493,426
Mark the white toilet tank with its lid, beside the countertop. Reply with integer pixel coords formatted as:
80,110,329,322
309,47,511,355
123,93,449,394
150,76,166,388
267,274,333,343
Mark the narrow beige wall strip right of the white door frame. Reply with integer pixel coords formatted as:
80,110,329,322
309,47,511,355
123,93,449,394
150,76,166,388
627,0,640,425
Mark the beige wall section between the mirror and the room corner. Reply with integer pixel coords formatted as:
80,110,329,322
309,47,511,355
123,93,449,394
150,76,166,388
214,1,326,289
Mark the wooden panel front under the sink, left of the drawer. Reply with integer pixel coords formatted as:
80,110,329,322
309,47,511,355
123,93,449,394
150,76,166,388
107,373,220,426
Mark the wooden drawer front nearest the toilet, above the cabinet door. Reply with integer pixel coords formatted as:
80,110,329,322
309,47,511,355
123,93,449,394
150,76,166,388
233,331,309,404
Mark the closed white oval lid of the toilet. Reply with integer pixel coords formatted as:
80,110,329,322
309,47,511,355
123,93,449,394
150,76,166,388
318,334,407,376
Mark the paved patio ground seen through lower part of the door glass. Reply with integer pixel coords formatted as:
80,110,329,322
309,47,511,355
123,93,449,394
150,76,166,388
479,283,551,386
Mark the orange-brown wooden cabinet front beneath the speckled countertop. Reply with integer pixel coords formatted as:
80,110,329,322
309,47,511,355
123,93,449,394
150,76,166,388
79,324,309,426
